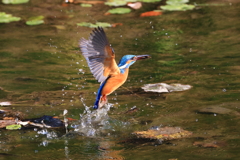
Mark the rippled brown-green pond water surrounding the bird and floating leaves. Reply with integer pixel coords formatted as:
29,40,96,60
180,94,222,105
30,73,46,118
0,0,240,160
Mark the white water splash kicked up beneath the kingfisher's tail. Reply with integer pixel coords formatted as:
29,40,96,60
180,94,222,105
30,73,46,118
34,98,130,140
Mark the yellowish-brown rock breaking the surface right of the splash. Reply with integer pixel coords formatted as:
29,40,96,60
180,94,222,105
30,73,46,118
133,127,192,141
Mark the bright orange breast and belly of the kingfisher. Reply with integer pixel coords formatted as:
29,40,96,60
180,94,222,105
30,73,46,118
101,68,129,95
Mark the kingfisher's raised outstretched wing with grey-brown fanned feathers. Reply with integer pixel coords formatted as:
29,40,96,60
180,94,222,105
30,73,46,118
79,27,120,82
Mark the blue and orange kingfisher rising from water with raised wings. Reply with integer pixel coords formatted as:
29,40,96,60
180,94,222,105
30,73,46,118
79,27,150,109
